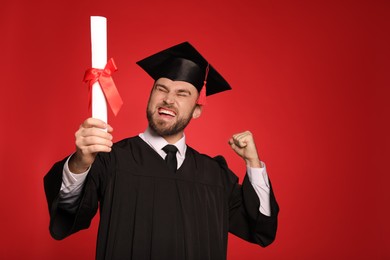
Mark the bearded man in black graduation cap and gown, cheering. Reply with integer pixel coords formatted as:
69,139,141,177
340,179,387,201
44,42,279,260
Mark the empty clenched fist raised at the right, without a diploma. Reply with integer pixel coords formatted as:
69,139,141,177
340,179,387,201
229,131,261,168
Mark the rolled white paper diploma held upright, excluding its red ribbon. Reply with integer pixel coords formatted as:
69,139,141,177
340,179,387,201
91,16,107,123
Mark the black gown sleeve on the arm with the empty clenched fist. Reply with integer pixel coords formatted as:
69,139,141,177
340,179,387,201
215,156,279,247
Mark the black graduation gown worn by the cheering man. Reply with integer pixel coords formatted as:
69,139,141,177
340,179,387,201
44,136,279,260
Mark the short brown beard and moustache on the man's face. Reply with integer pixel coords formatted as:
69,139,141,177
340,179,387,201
146,105,195,136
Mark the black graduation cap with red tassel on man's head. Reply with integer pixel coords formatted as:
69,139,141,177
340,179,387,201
137,42,231,105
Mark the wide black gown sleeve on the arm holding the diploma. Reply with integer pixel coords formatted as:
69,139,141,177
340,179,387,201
44,155,111,240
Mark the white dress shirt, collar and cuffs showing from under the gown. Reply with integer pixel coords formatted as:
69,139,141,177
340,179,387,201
59,128,271,216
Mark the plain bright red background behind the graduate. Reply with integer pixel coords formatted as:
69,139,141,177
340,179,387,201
0,0,390,259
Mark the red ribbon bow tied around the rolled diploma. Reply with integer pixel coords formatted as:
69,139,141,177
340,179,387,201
84,58,123,116
